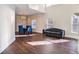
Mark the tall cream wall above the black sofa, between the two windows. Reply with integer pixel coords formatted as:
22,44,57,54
47,4,79,39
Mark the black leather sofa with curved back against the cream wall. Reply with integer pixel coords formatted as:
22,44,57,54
43,28,65,38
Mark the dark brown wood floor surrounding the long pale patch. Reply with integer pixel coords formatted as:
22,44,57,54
2,34,78,54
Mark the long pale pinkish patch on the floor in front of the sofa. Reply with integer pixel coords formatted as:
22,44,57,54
26,39,70,45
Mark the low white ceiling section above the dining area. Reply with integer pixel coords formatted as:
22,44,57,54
15,4,45,15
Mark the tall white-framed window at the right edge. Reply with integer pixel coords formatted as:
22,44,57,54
71,15,79,34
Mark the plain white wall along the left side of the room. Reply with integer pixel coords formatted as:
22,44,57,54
0,5,15,53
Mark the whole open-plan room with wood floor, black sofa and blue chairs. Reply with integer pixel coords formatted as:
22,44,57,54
0,4,79,54
